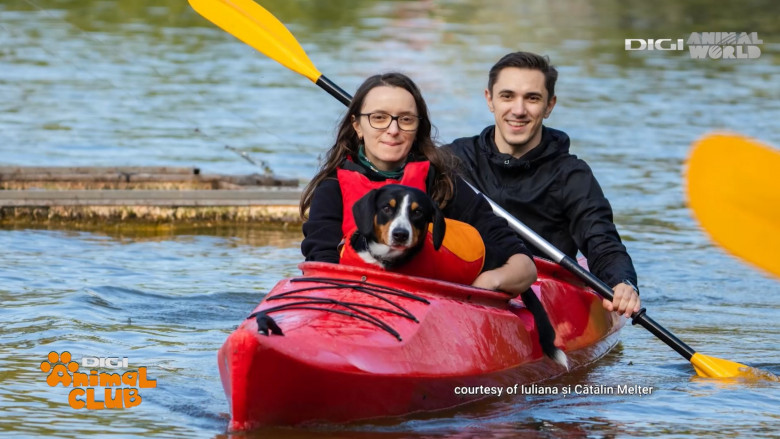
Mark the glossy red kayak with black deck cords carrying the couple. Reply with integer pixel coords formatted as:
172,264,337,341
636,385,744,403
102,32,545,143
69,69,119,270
218,259,625,431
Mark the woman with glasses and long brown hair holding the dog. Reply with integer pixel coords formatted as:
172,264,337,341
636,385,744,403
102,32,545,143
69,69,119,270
301,73,536,297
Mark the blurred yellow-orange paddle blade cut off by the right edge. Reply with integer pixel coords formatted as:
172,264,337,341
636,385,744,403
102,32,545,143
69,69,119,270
687,134,780,276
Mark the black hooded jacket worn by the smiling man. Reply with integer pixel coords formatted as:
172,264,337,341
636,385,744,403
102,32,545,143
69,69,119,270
448,126,637,287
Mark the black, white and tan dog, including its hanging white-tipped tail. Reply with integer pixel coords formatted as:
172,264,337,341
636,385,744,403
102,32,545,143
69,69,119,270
350,184,569,369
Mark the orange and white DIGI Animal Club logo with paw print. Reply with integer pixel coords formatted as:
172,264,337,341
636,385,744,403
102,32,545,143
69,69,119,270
41,351,157,410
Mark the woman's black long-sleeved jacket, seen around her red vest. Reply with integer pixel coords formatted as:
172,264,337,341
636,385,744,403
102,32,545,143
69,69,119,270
301,162,532,271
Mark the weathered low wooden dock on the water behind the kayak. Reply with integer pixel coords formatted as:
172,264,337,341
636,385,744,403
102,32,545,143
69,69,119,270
0,166,301,225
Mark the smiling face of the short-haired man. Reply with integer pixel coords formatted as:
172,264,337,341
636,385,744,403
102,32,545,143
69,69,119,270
485,67,556,157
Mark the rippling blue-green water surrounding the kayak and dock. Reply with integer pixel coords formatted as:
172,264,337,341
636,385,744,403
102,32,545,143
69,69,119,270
0,0,780,438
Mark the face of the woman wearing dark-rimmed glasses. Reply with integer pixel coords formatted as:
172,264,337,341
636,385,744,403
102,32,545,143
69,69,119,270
352,85,419,171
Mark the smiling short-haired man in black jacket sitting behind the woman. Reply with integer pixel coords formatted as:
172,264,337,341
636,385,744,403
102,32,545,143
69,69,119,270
450,52,640,316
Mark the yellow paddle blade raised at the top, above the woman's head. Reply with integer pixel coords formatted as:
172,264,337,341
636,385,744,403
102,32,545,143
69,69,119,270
189,0,322,82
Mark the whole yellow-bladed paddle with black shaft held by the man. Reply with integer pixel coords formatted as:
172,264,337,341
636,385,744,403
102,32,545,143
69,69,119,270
189,0,768,378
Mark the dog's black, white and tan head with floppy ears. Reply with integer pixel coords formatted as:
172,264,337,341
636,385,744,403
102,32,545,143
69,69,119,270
352,184,445,262
